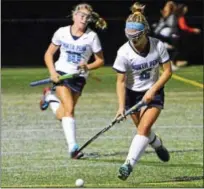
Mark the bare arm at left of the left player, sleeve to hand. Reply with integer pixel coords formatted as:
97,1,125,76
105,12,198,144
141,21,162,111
44,43,59,83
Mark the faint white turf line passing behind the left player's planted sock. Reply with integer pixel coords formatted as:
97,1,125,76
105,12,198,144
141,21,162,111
1,125,204,134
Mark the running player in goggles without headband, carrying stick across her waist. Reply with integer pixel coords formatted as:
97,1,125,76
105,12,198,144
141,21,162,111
40,3,107,159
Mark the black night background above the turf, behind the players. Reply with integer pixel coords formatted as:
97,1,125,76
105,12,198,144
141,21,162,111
1,0,203,67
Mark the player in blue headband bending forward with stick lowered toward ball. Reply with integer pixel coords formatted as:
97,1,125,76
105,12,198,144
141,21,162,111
113,2,172,180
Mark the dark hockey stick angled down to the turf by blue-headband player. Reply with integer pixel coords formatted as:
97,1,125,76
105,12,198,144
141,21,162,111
75,101,146,157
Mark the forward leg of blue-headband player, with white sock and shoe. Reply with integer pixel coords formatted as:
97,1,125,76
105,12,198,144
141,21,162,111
118,107,161,180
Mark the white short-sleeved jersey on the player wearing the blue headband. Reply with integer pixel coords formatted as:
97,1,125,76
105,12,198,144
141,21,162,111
113,37,169,92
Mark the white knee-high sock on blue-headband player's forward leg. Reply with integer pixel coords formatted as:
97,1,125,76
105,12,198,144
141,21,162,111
126,134,149,167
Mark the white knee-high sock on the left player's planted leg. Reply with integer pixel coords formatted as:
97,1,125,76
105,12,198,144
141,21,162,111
62,117,76,152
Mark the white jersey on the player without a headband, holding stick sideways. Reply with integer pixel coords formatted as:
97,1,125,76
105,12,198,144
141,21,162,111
52,26,102,77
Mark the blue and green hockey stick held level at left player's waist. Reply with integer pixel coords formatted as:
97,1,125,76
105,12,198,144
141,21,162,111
30,72,81,87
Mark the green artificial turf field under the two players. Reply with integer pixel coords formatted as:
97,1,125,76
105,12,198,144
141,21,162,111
1,66,203,188
